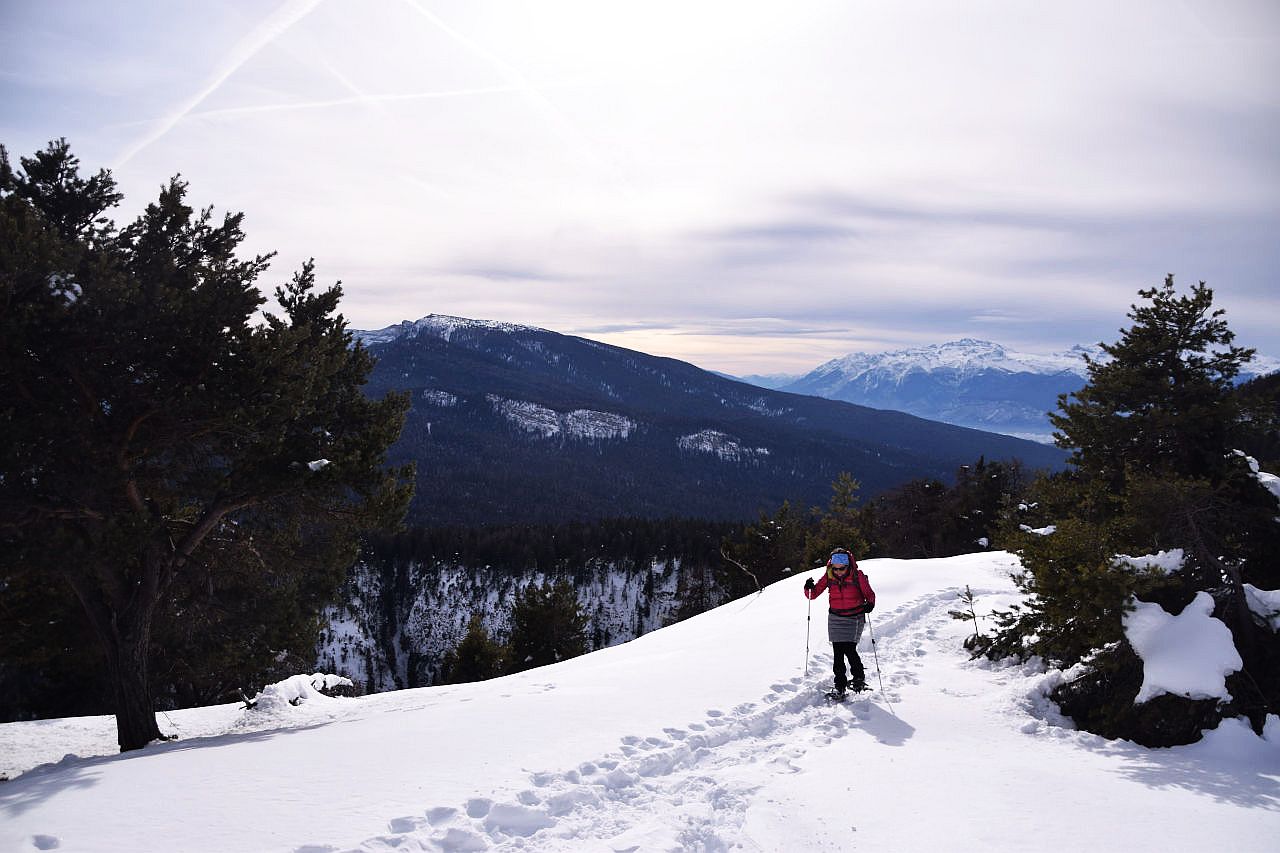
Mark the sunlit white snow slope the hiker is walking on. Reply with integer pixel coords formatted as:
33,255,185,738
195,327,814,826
0,552,1280,853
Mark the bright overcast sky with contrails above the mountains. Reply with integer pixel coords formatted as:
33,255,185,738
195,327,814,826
0,0,1280,374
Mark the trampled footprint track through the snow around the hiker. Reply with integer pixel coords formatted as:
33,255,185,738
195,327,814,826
337,589,967,853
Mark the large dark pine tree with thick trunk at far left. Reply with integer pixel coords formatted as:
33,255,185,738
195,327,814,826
0,142,408,749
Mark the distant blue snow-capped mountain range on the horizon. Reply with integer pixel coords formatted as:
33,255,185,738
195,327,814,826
742,338,1280,442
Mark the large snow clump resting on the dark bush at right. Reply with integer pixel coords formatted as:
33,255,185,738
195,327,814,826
1124,592,1239,701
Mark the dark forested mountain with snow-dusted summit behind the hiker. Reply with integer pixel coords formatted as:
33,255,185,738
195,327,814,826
356,315,1064,524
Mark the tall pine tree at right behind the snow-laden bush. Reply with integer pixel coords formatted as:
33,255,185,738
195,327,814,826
996,277,1280,686
